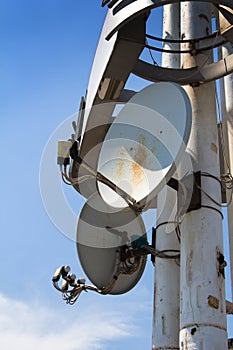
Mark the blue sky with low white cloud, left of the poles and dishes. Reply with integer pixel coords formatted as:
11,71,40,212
0,0,233,350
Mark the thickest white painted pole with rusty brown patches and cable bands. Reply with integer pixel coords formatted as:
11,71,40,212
180,1,227,350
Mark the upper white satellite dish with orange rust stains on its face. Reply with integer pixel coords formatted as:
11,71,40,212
98,82,192,208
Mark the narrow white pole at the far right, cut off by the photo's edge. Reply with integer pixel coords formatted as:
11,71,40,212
222,43,233,300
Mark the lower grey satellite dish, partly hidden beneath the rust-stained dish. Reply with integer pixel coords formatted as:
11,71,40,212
76,193,147,294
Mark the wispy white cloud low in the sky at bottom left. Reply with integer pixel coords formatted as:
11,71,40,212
0,294,137,350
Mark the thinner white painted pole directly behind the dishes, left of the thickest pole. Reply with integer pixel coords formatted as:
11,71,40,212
152,4,180,350
